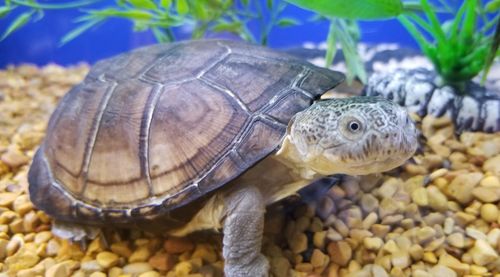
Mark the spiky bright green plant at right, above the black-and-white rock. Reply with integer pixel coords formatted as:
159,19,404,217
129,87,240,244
398,0,500,93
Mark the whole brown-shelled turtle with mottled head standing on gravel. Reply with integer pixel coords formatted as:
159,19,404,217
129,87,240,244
28,39,418,277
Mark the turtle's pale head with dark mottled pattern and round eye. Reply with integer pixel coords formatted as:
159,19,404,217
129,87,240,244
287,97,418,175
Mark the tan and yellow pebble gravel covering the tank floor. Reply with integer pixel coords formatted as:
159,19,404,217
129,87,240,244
0,65,500,277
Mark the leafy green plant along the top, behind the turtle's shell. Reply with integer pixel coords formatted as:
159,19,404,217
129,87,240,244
0,0,299,44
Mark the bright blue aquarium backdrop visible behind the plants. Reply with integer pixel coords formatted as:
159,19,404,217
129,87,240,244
0,1,468,68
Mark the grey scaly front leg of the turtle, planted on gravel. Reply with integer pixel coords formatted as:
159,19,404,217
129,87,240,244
222,183,269,277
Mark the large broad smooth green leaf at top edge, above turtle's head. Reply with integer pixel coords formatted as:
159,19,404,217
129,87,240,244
285,0,404,19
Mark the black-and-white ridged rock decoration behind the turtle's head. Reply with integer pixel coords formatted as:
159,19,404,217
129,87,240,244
364,69,500,132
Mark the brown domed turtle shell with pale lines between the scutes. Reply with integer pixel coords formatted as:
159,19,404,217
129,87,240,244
29,40,343,223
